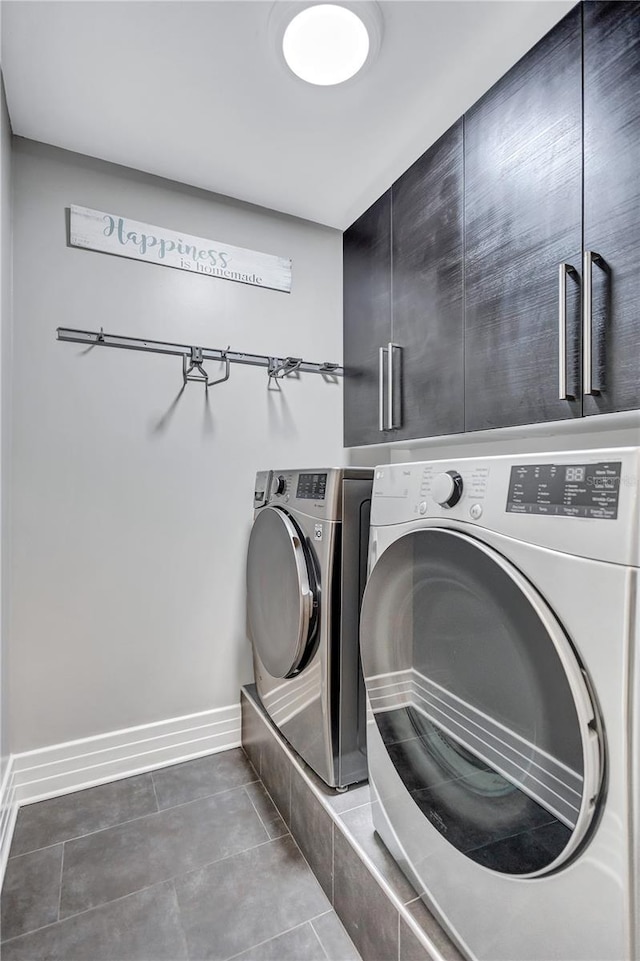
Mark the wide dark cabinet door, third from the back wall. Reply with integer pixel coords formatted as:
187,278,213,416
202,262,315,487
464,7,582,430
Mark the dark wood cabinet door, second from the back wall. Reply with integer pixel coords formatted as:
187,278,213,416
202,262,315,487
391,120,464,440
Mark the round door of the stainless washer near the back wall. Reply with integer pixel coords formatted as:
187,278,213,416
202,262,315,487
247,507,318,677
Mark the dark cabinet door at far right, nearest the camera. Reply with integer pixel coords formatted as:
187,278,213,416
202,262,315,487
584,3,640,414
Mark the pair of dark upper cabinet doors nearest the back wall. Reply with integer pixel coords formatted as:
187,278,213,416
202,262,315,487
344,120,464,446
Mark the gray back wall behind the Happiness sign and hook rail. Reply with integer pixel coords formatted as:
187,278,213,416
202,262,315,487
10,139,344,752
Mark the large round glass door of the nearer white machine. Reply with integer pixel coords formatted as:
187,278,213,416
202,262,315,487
360,528,602,876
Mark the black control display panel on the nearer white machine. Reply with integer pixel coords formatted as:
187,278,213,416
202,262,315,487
506,461,622,520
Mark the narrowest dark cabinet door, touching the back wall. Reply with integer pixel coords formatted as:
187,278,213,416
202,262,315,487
343,190,391,447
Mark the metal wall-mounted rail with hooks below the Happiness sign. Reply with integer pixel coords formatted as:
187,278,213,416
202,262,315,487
57,327,344,387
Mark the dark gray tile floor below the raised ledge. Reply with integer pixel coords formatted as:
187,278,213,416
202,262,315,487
1,749,359,961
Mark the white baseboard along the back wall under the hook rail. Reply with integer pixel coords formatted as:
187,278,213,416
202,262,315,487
11,703,241,808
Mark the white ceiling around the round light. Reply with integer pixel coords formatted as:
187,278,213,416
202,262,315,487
2,0,573,229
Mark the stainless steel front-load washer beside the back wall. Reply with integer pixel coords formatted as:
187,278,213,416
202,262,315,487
247,468,373,788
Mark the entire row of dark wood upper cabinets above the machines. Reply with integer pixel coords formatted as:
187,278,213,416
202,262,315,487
344,0,640,445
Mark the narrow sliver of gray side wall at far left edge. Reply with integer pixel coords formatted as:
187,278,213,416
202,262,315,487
0,76,11,783
